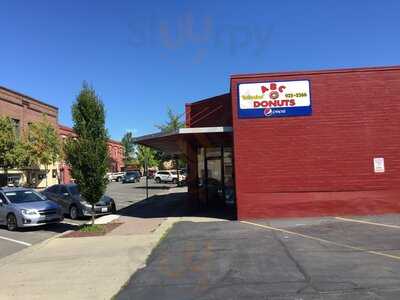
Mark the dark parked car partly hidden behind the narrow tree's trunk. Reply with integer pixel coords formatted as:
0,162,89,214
42,183,116,219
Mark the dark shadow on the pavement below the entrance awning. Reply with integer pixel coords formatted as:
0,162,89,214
118,192,236,220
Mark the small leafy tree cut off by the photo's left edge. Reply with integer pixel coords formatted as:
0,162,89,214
0,117,20,184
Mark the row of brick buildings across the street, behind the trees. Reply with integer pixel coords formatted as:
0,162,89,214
0,86,124,187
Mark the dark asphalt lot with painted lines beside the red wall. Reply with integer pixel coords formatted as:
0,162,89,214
116,215,400,299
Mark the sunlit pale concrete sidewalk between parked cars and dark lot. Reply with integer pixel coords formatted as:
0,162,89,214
0,217,225,300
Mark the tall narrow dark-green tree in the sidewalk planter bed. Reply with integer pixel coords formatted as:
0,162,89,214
65,83,108,225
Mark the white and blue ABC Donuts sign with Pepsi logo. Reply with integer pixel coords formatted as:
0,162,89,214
238,80,312,118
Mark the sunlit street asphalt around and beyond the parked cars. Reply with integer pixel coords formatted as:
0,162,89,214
0,178,183,258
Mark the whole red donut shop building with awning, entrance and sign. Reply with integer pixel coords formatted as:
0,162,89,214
137,67,400,219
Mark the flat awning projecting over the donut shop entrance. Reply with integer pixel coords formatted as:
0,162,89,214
134,127,232,155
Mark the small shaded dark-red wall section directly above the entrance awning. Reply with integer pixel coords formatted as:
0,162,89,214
185,94,232,127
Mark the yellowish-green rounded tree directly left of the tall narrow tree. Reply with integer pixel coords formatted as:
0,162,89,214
26,116,61,187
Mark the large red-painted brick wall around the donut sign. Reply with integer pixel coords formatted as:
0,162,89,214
231,68,400,219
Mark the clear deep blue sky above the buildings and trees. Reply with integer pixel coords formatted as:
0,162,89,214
0,0,400,139
